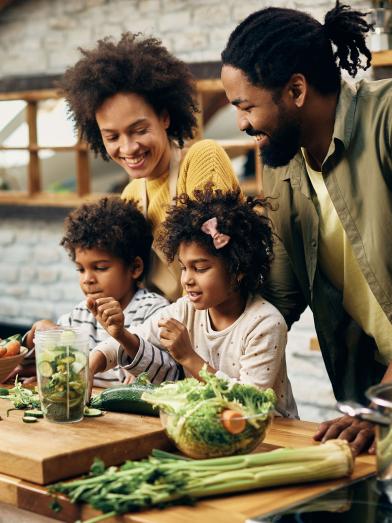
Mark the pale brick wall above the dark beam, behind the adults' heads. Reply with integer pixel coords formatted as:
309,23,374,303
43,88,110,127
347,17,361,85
0,0,370,78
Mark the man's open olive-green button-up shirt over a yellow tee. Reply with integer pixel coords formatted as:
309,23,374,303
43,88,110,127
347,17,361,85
263,80,392,401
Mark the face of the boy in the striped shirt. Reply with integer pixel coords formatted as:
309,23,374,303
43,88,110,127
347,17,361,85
75,247,136,309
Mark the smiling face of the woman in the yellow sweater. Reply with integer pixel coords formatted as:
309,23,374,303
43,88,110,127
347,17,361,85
95,93,170,183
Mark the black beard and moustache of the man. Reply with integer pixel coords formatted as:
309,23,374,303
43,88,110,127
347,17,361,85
246,107,301,167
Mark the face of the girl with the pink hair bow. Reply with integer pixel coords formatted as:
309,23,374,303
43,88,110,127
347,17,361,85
178,242,240,316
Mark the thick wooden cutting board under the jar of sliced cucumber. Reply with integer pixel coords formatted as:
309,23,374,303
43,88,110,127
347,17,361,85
0,399,170,485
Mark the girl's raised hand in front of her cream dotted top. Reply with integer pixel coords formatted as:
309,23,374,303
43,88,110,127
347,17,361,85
158,318,196,366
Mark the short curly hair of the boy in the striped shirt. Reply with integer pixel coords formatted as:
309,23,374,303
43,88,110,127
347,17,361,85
60,196,153,278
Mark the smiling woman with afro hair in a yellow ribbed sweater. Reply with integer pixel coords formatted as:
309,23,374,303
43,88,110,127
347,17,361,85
62,33,238,300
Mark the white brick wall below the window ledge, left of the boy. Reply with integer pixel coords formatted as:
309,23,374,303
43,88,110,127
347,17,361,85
0,217,83,327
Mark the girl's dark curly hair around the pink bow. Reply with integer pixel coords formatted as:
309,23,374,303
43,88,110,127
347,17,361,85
157,183,273,294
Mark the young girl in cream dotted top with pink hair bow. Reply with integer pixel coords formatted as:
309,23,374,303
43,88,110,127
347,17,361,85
89,186,297,416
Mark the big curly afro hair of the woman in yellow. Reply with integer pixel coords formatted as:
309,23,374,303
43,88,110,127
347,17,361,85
59,33,197,160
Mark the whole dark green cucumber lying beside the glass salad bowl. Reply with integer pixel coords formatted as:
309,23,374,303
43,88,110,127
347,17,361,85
90,383,159,416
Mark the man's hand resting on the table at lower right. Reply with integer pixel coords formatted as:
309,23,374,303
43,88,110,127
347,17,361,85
313,416,375,456
